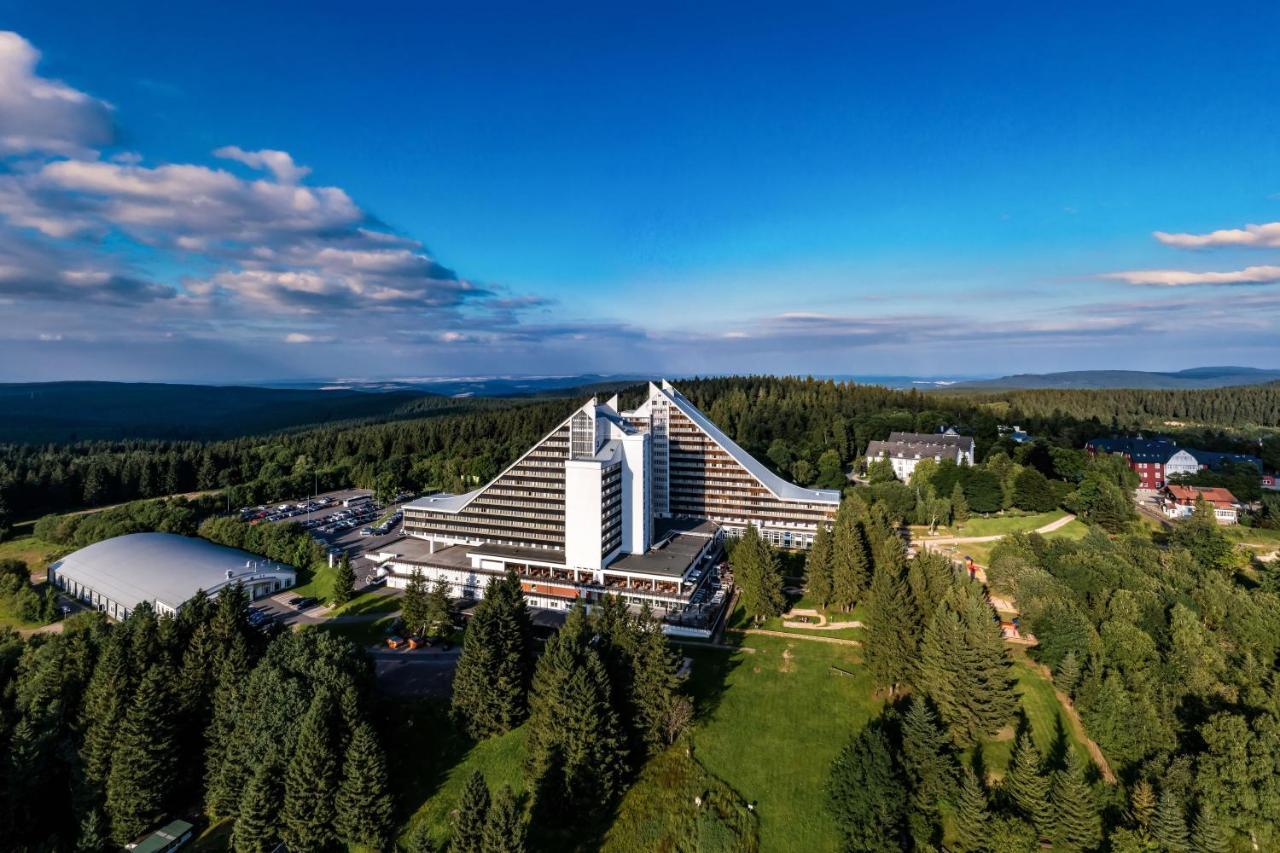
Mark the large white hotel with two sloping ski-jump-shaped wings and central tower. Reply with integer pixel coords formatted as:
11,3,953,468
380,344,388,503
372,382,840,622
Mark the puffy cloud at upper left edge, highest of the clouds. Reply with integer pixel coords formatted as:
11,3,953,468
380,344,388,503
0,31,115,156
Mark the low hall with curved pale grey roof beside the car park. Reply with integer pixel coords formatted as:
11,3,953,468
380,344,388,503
49,533,297,619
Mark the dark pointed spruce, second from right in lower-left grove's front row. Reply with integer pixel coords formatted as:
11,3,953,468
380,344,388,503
280,690,338,853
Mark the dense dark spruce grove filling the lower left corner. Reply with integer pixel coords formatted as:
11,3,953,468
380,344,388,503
0,585,394,853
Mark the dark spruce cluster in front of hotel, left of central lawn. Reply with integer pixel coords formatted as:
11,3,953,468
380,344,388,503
435,573,692,852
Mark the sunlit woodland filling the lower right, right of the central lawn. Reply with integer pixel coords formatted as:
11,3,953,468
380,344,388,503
798,476,1280,853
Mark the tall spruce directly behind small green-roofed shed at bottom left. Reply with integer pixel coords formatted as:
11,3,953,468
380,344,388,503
106,663,178,845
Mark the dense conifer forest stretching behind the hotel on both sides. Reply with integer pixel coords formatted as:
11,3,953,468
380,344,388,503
0,377,1280,528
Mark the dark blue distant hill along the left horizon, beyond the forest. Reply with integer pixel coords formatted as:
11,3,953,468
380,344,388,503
0,382,445,443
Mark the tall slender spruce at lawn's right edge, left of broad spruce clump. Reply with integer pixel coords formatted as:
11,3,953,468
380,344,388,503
863,543,919,695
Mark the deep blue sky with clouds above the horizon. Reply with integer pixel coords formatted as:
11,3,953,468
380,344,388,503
0,0,1280,382
